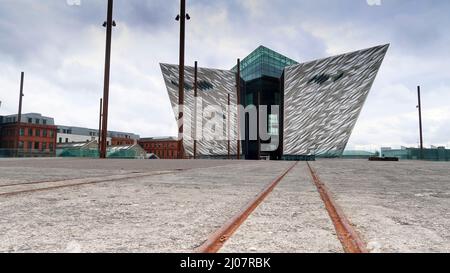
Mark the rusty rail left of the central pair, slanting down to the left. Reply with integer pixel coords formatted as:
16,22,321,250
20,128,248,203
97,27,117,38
196,162,298,253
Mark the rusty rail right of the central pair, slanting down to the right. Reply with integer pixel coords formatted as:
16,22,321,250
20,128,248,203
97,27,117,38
307,163,368,253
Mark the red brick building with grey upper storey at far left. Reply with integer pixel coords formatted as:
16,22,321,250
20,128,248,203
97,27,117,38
0,113,57,157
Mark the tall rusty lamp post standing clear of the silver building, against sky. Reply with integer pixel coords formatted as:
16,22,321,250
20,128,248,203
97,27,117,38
100,0,116,159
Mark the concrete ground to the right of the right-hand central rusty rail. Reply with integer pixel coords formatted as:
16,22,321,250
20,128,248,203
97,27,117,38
312,160,450,253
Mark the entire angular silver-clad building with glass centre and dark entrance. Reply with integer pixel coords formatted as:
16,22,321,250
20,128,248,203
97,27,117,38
161,45,389,160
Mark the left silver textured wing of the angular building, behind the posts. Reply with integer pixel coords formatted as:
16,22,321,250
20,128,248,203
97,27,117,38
161,64,237,157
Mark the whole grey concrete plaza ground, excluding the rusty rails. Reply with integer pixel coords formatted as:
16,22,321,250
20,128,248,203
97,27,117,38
0,159,450,252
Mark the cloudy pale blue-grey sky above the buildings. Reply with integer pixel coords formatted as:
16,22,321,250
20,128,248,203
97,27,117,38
0,0,450,150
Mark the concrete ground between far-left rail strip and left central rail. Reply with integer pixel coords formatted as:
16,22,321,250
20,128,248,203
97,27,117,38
0,159,289,252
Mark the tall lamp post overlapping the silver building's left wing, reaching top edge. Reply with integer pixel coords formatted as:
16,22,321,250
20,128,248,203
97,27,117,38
175,0,191,159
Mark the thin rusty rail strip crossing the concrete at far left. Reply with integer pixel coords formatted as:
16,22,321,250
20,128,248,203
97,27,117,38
0,171,176,197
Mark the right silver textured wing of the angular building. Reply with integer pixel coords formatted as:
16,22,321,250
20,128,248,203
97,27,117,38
283,45,389,156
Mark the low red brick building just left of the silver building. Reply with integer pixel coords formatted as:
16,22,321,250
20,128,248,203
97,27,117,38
139,137,180,159
